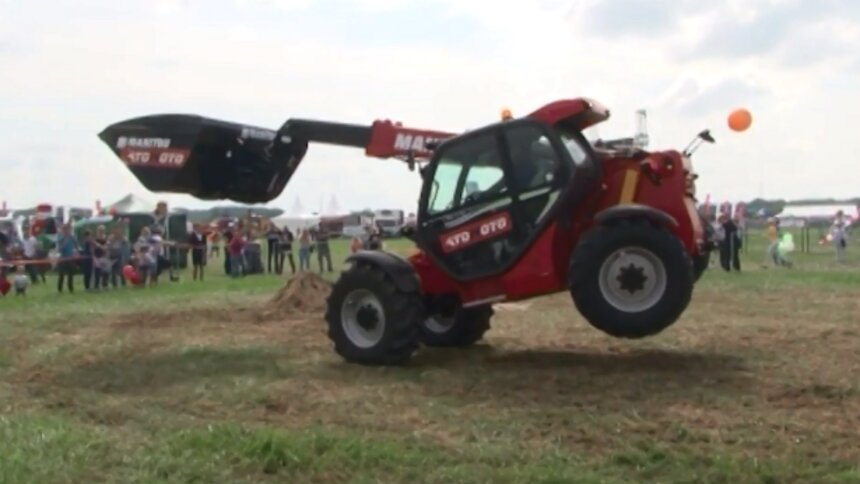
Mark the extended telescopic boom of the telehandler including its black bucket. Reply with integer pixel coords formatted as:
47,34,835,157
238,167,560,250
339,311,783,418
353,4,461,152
99,114,455,203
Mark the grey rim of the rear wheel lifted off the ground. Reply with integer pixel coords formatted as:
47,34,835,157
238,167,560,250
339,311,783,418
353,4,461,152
600,247,666,313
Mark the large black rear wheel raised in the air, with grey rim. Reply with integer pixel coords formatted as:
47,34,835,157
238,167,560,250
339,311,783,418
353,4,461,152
569,220,694,338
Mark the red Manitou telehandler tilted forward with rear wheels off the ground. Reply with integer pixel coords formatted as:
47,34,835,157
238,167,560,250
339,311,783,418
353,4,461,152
99,98,713,364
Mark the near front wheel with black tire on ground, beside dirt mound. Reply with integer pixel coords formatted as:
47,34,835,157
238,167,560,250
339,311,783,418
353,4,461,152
325,264,424,365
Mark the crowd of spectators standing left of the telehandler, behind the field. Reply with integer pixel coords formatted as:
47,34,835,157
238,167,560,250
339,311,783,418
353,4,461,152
0,216,390,295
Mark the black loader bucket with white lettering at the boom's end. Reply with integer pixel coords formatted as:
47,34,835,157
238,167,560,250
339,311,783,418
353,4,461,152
99,114,308,203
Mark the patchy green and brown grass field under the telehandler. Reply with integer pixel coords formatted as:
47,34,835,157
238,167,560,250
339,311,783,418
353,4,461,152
0,233,860,484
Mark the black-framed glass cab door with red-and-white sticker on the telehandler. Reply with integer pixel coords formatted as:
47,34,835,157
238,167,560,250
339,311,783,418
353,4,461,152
416,119,573,281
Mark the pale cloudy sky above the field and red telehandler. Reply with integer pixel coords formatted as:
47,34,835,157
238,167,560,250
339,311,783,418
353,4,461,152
0,0,860,212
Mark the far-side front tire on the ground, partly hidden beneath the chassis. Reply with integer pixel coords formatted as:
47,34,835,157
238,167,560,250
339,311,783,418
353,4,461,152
420,306,493,348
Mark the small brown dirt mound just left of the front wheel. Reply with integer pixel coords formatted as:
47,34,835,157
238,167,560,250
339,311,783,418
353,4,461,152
264,272,331,317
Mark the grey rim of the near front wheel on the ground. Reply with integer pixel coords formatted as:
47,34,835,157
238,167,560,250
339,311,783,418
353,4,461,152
340,289,385,348
